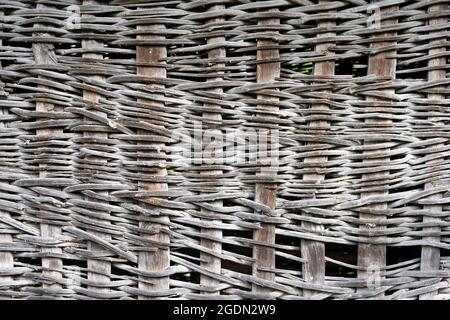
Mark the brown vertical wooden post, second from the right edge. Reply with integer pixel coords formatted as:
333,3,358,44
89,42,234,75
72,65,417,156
358,1,398,298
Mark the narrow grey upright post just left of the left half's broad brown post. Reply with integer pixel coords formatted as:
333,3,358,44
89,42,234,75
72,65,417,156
82,0,111,292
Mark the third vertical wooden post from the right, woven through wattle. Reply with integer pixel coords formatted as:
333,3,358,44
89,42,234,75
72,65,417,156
301,8,335,296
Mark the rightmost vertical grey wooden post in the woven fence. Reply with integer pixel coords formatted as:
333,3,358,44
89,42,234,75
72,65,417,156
419,4,448,300
